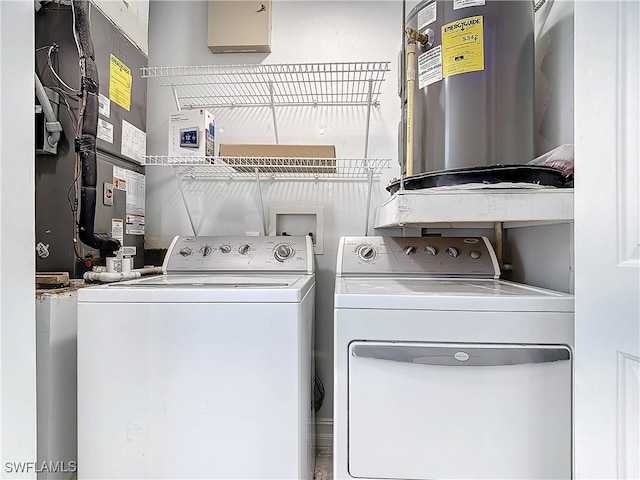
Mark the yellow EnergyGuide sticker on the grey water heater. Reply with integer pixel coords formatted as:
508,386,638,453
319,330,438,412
442,15,484,77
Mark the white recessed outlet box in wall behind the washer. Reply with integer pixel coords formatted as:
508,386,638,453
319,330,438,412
269,206,324,255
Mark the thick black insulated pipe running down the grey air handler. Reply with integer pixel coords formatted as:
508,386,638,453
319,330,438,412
71,0,120,256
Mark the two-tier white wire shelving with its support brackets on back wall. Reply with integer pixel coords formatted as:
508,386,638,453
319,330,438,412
142,61,391,234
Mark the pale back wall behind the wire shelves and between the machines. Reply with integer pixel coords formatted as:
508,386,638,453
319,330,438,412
146,0,402,418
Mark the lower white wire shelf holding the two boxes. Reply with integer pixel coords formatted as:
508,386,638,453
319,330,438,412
145,155,391,180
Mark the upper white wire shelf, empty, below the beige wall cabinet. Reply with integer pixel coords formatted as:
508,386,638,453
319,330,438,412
142,61,390,109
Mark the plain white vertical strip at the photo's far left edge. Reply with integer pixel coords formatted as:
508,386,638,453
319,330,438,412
0,0,36,478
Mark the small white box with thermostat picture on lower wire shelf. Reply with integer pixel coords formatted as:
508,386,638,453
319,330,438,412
167,108,215,157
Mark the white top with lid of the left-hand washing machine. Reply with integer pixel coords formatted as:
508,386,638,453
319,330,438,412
78,273,315,303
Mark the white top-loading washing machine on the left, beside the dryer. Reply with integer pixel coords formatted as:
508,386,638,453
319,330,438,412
78,237,315,480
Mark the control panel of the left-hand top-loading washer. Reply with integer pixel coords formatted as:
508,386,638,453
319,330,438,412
162,236,315,274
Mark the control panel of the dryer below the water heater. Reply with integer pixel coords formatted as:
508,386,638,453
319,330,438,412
336,236,500,278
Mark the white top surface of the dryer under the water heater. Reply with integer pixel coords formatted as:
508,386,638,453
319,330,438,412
334,277,574,312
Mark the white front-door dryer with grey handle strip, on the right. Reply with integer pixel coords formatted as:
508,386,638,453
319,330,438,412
333,237,574,480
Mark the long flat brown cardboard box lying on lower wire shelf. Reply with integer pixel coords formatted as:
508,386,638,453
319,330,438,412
220,143,336,173
